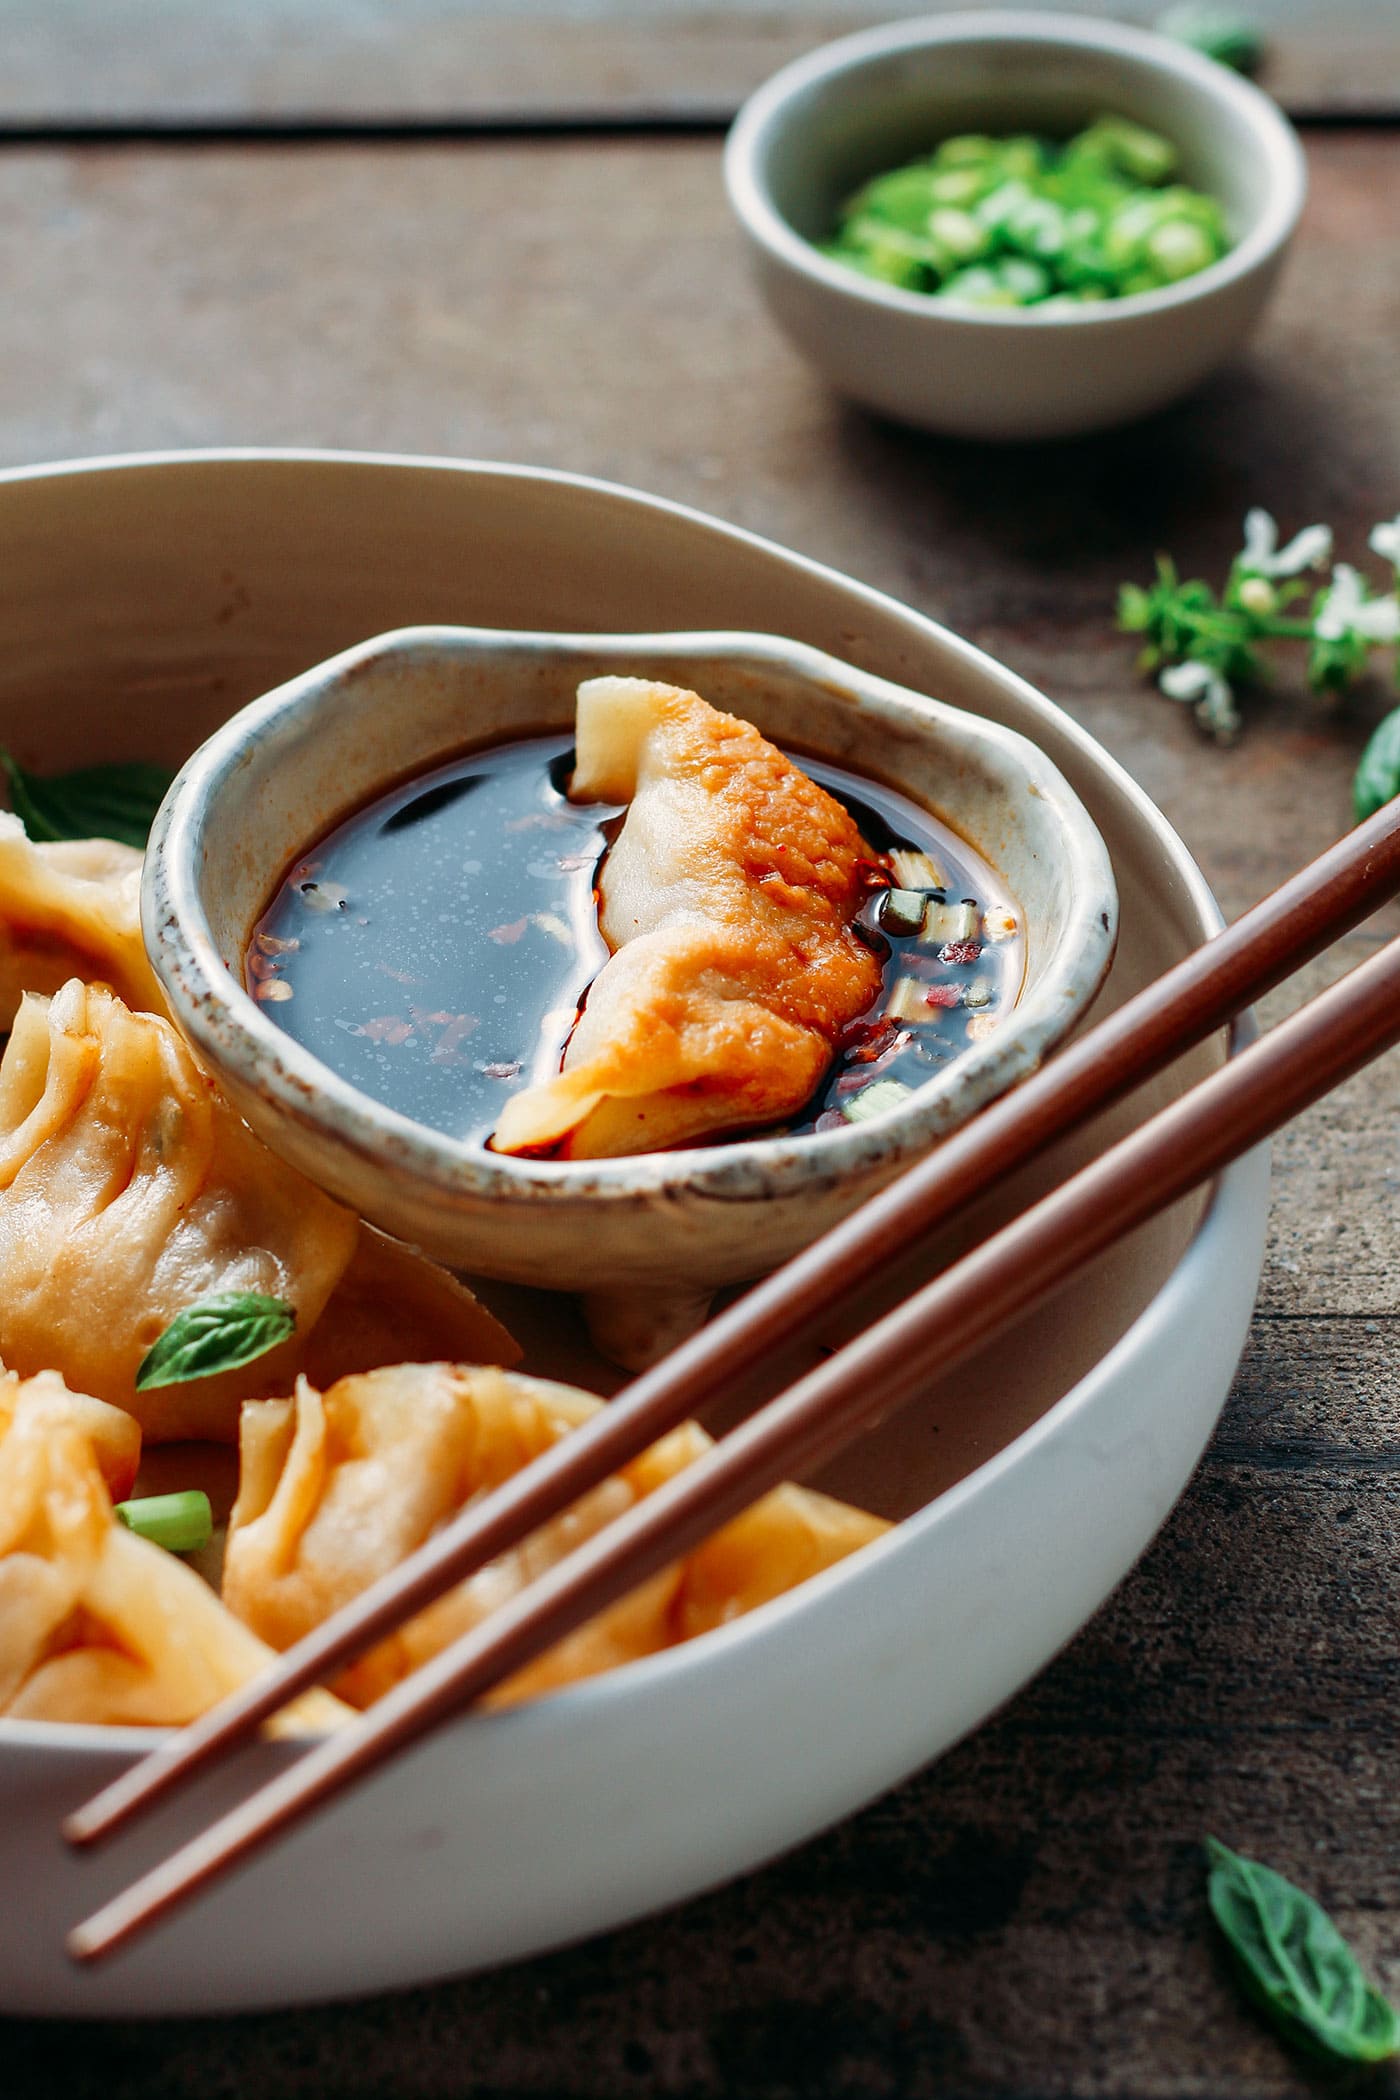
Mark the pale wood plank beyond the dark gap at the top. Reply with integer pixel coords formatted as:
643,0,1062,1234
0,0,1400,128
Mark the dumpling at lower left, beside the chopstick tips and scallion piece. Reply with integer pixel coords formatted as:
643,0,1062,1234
0,1378,346,1733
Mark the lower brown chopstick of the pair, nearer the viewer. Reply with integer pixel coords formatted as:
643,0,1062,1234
69,923,1400,1961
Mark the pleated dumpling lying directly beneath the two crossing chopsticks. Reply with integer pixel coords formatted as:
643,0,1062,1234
222,1363,890,1705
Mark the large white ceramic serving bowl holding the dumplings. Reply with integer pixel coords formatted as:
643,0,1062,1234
0,454,1268,2014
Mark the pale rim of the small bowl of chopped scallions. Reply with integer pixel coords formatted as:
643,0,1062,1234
724,8,1308,330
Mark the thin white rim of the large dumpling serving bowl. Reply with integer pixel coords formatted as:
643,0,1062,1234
0,445,1253,1762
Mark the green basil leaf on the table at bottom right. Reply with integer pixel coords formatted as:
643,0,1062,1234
1205,1838,1400,2064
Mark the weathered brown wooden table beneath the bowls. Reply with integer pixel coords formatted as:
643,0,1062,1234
0,0,1400,2100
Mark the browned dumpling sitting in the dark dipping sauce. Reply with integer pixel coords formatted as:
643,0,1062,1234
491,678,882,1159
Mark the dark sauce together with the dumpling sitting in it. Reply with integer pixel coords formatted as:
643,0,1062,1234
246,678,1024,1159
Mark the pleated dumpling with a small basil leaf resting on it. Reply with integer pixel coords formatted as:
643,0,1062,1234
0,979,518,1443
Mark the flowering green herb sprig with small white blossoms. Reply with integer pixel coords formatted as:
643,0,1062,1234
1119,510,1400,819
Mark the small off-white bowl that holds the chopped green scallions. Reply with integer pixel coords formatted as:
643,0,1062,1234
724,8,1308,439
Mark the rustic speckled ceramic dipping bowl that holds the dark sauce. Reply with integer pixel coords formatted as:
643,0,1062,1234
143,628,1117,1363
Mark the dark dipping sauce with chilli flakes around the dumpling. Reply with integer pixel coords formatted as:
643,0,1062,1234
246,735,1024,1145
